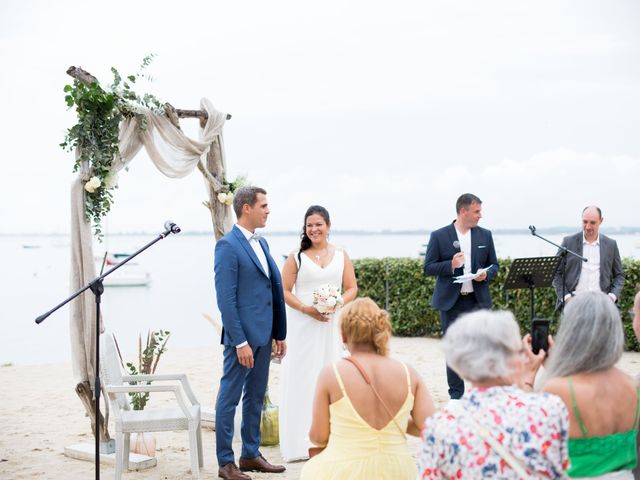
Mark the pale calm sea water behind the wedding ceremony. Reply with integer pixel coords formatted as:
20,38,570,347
0,232,640,365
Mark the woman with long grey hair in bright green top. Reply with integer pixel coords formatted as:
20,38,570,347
543,291,640,479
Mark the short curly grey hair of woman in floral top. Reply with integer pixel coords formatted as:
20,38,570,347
443,310,522,382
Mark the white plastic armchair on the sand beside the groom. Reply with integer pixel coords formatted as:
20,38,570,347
100,334,202,480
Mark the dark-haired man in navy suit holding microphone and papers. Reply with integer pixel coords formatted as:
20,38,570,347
424,193,498,399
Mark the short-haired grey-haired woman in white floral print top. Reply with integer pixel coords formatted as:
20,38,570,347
418,310,569,479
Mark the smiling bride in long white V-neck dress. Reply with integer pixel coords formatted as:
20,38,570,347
279,205,358,462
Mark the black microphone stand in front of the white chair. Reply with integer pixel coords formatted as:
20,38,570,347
36,222,180,480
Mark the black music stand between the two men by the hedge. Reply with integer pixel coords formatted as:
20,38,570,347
502,256,562,320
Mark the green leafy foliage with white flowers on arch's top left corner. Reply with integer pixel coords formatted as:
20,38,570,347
60,54,164,240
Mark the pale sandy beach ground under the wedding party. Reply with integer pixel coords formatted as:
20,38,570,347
0,338,640,480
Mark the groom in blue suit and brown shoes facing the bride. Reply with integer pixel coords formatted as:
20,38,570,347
215,187,287,480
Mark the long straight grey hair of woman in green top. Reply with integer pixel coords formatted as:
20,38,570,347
545,292,624,378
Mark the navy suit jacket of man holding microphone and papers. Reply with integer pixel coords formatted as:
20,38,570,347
424,223,499,312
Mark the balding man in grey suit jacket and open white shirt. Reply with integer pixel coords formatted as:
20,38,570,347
553,206,624,307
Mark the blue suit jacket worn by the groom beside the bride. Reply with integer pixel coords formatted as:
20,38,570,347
214,226,287,347
